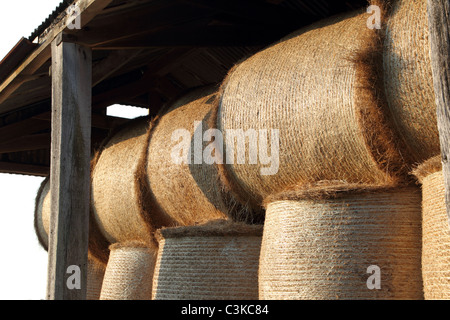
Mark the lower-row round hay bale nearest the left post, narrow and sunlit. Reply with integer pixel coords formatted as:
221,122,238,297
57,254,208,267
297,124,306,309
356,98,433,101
100,241,157,300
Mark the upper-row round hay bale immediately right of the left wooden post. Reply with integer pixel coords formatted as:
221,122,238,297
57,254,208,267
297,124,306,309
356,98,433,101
91,117,155,244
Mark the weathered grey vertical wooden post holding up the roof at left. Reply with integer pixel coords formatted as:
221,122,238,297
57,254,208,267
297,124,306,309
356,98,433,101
47,35,92,300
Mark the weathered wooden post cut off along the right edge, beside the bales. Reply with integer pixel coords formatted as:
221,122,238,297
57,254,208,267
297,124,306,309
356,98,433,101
427,0,450,229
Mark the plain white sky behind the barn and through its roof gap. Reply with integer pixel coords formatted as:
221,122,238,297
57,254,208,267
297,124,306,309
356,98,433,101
0,0,147,300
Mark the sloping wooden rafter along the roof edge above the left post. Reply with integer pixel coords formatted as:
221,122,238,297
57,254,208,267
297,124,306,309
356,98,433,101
0,0,112,107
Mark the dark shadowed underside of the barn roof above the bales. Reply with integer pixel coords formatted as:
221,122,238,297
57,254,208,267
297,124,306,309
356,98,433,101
0,0,367,176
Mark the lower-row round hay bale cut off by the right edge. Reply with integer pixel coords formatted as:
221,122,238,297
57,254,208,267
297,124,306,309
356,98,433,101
414,155,450,300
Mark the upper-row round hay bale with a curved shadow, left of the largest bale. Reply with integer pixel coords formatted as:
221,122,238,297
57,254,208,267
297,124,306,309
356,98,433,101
141,87,246,229
